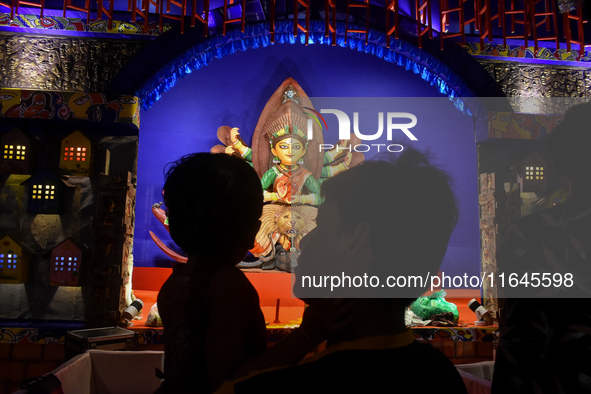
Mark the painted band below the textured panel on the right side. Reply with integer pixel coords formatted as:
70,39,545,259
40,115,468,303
488,112,563,140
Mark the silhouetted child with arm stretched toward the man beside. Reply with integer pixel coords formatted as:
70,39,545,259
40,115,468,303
157,153,344,393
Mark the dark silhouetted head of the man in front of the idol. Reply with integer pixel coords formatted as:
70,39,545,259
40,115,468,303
298,150,458,298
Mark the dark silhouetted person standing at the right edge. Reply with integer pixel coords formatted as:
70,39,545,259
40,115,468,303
492,103,591,394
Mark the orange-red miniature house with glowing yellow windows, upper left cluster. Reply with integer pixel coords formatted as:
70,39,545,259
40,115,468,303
59,131,93,176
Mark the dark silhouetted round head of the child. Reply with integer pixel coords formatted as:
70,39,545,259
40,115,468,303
163,153,263,263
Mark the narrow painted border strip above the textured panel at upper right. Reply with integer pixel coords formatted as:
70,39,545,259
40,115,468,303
463,42,591,63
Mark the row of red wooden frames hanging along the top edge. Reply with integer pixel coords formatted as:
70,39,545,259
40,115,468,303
0,0,591,54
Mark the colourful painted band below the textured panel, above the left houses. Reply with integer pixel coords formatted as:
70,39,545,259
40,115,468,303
0,89,140,129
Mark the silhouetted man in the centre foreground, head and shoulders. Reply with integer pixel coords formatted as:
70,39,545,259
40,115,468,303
220,150,466,394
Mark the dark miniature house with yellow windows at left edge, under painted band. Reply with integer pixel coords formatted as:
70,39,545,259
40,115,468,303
0,129,33,174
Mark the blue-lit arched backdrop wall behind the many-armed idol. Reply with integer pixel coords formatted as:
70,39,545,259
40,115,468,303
134,40,480,275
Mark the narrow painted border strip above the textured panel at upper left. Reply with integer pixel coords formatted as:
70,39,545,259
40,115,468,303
0,14,172,36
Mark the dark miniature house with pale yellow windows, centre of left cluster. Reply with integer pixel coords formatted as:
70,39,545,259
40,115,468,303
27,170,61,214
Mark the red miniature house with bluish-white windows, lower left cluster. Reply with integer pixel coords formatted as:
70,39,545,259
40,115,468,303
49,239,82,286
